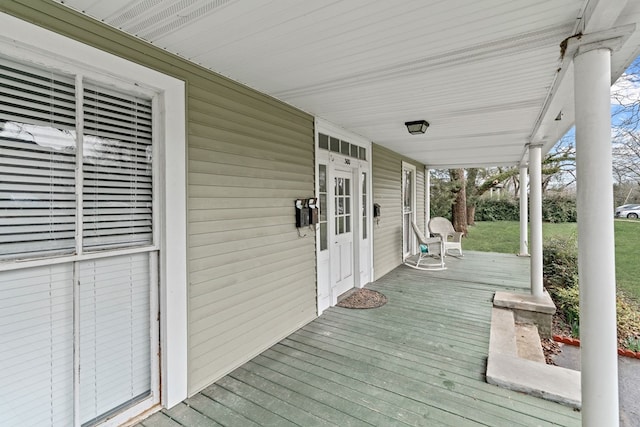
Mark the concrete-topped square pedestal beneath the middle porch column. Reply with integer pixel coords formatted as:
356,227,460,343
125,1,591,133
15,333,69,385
493,291,556,338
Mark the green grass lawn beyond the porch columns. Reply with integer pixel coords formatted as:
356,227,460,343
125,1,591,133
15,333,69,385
462,219,640,301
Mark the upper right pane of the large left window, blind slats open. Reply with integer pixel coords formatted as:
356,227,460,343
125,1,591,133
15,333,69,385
82,84,153,249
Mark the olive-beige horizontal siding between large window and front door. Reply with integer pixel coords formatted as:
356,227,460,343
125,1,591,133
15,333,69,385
188,83,316,393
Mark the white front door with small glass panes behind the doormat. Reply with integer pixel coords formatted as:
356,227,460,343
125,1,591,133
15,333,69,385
329,170,354,300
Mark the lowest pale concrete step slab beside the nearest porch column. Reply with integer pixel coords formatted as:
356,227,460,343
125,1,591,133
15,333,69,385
487,351,582,408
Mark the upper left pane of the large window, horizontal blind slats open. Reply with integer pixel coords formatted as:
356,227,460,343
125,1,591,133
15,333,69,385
0,59,76,259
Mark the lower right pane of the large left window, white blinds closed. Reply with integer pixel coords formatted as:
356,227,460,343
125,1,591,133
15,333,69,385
80,253,151,423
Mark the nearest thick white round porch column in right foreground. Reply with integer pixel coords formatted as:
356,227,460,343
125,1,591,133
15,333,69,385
574,45,619,426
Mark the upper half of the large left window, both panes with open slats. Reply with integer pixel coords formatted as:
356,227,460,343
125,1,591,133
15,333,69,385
0,58,153,260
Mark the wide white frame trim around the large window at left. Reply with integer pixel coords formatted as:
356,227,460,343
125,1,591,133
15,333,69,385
0,13,188,416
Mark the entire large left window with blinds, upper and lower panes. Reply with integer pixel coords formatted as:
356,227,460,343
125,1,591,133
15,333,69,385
0,56,158,426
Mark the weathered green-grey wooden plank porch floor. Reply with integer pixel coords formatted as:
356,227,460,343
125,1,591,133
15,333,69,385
139,252,580,427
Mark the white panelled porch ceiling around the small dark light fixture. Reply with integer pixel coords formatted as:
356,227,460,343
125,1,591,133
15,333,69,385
52,0,640,168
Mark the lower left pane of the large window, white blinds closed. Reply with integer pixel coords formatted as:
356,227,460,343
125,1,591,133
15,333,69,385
0,264,73,426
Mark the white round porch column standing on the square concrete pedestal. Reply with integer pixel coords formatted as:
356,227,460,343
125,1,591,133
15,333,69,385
529,144,542,297
